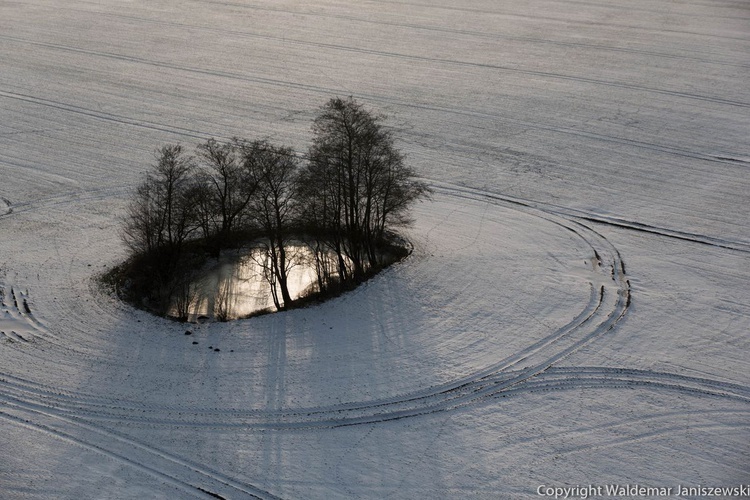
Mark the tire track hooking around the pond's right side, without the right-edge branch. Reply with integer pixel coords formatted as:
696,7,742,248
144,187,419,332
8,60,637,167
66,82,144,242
3,186,630,428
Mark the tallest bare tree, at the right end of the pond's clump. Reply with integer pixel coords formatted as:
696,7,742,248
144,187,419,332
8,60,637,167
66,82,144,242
302,97,429,282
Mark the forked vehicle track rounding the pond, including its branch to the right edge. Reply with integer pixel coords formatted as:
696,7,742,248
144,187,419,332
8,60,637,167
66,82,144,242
5,185,750,429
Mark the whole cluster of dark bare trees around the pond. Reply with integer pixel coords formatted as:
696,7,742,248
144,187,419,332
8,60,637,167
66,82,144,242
122,98,428,313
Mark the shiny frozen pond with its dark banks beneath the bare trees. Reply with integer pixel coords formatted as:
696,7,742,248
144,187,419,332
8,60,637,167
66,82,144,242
100,234,412,323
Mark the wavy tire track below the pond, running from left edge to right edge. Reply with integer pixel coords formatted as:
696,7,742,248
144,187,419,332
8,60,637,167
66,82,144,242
4,367,750,430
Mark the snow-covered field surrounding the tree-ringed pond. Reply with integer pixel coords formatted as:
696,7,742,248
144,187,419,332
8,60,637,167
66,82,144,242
0,0,750,499
